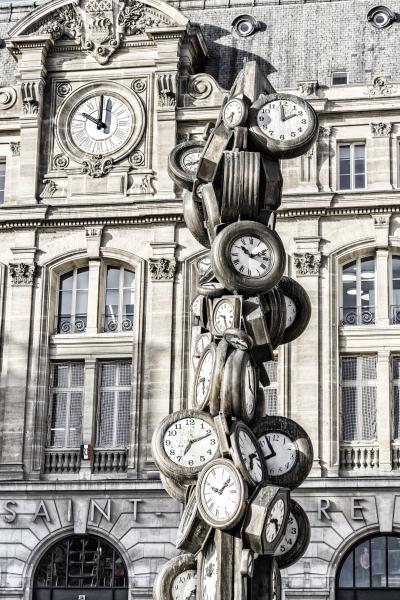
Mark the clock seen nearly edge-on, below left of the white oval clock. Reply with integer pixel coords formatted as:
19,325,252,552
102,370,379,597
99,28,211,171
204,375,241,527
176,489,210,554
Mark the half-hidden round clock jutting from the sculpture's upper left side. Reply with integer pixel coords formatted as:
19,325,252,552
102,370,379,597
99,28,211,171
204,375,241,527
168,140,205,191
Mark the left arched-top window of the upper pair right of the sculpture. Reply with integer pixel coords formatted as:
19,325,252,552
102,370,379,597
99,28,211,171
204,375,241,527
341,256,375,325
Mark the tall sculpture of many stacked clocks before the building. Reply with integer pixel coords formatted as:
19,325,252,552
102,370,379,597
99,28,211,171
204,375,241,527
152,63,318,600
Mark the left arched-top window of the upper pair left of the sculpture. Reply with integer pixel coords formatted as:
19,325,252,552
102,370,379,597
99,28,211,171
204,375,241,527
57,267,89,333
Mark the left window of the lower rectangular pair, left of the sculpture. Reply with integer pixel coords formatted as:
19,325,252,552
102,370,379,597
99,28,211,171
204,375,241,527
48,362,84,448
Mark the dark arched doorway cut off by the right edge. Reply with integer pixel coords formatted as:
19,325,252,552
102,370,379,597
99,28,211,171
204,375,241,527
336,535,400,600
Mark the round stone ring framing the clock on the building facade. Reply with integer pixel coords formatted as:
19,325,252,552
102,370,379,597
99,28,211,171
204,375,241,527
55,81,146,162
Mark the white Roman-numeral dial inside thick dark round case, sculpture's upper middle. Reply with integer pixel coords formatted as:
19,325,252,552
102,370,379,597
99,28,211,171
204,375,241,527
230,235,272,278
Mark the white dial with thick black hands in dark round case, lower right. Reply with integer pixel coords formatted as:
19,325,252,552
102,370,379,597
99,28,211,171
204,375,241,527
258,432,297,475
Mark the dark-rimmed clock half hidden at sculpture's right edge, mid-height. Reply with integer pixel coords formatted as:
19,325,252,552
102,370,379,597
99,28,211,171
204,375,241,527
278,277,311,344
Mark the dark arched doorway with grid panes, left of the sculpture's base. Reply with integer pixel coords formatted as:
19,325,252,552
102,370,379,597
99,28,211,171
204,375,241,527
33,535,128,600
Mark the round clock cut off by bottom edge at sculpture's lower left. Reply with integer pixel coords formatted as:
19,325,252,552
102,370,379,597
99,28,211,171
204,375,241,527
153,554,197,600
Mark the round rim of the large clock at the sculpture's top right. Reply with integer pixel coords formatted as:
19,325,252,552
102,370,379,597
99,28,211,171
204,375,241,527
249,93,319,159
